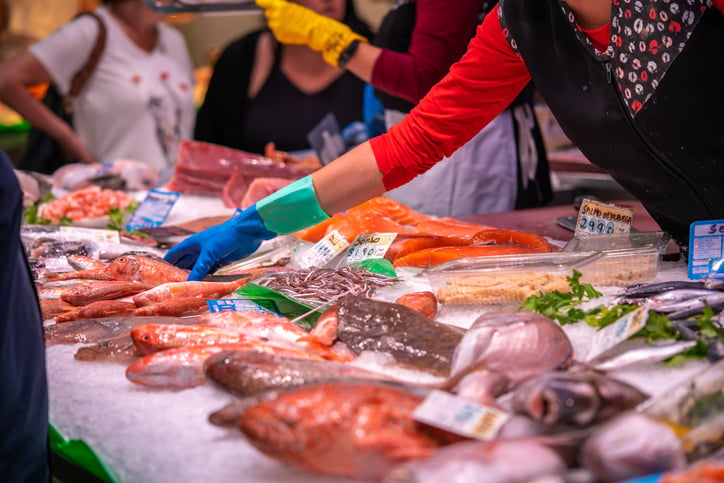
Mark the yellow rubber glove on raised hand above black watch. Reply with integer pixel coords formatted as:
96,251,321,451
256,0,367,67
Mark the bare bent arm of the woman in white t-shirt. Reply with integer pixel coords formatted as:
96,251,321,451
0,51,95,162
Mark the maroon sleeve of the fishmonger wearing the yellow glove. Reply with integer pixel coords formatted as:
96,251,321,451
371,0,482,104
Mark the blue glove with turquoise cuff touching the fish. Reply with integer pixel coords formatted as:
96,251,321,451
164,175,329,280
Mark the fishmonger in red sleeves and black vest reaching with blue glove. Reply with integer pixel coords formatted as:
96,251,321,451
166,0,724,279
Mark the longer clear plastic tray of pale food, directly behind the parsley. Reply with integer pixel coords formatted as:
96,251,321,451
419,251,603,305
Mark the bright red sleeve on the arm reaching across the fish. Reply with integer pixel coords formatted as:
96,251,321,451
370,7,530,189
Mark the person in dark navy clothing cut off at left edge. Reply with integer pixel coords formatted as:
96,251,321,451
0,150,50,483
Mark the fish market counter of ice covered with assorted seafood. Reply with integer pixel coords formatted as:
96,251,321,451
23,144,724,482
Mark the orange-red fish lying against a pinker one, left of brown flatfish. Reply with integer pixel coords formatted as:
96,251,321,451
131,324,247,355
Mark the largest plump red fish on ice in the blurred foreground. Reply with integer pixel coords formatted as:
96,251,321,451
238,381,448,479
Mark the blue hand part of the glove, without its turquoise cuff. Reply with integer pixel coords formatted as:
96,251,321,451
164,205,277,280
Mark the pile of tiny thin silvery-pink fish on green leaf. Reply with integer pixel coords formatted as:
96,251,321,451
255,267,400,306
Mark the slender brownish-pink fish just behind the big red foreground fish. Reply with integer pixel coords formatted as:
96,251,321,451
205,350,390,396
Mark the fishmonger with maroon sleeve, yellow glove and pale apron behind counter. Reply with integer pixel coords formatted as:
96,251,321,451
257,0,553,216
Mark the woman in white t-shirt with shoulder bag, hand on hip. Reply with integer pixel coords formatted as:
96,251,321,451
0,0,195,171
